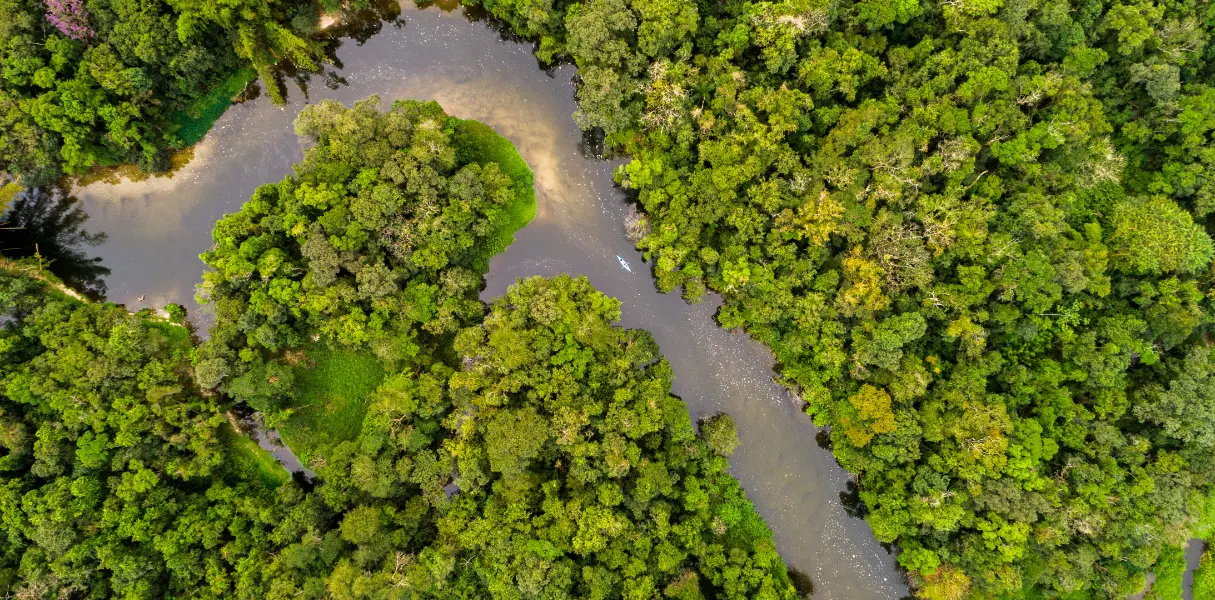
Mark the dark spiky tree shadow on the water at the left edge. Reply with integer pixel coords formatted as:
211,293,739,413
0,188,109,300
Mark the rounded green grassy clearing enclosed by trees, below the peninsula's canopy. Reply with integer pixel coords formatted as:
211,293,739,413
278,345,384,464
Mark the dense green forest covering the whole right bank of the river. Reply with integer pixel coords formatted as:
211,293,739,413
459,0,1215,598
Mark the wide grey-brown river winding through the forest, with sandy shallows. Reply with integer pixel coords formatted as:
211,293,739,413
75,2,906,600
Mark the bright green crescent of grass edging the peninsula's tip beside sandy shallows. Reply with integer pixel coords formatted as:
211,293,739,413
452,118,536,271
